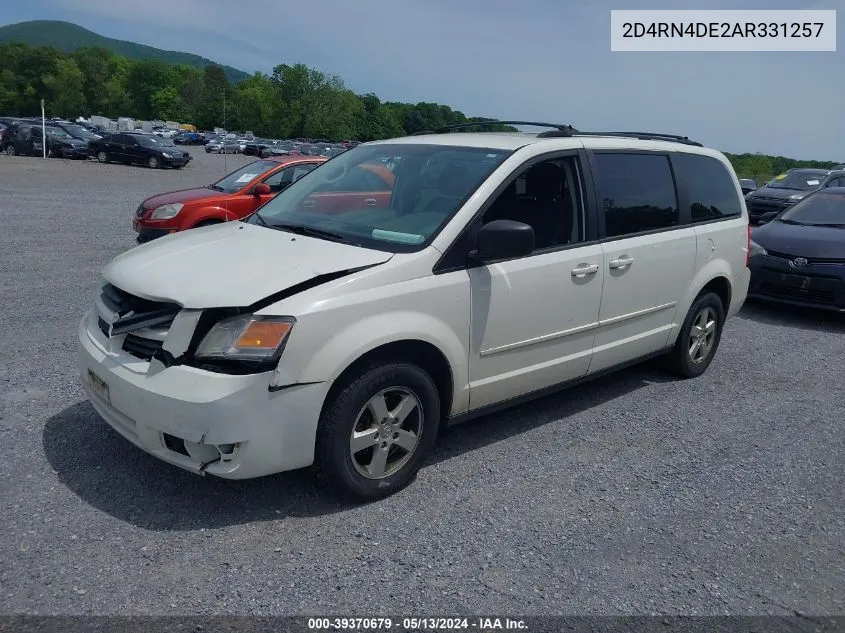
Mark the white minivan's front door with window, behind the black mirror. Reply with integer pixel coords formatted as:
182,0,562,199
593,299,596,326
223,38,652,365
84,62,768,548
469,154,605,409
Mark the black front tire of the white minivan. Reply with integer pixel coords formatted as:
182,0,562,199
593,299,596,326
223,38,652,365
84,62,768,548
314,360,440,500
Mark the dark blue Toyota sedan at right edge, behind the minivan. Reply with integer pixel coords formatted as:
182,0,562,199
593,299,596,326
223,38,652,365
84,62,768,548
748,187,845,312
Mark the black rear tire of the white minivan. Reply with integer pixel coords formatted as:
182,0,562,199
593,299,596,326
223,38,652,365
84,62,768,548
667,292,725,378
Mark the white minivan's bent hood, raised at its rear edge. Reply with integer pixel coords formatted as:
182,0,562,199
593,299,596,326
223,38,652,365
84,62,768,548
103,222,393,309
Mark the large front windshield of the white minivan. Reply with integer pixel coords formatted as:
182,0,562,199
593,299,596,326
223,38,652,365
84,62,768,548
248,143,511,252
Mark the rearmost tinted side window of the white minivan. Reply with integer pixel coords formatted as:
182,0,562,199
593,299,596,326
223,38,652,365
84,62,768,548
672,153,742,222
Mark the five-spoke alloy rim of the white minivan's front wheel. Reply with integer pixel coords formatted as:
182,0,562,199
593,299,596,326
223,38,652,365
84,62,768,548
349,387,425,479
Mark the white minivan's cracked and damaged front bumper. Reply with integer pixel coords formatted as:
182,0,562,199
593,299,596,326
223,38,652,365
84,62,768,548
79,310,329,479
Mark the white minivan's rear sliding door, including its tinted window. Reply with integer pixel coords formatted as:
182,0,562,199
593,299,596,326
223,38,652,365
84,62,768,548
590,152,696,373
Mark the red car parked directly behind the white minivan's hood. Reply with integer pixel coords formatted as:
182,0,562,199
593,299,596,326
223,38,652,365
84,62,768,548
133,156,327,243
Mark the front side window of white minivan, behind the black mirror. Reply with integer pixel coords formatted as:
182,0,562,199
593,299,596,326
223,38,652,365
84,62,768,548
482,156,585,251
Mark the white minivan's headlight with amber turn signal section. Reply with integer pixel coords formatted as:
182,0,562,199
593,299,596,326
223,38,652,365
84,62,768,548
194,314,296,361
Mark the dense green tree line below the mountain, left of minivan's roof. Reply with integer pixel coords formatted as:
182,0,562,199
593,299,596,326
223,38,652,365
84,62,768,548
0,43,513,141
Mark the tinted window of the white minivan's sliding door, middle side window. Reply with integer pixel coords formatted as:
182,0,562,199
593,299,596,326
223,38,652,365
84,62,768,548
595,153,678,237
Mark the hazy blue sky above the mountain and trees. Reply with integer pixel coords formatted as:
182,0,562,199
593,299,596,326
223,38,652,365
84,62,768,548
0,0,845,162
